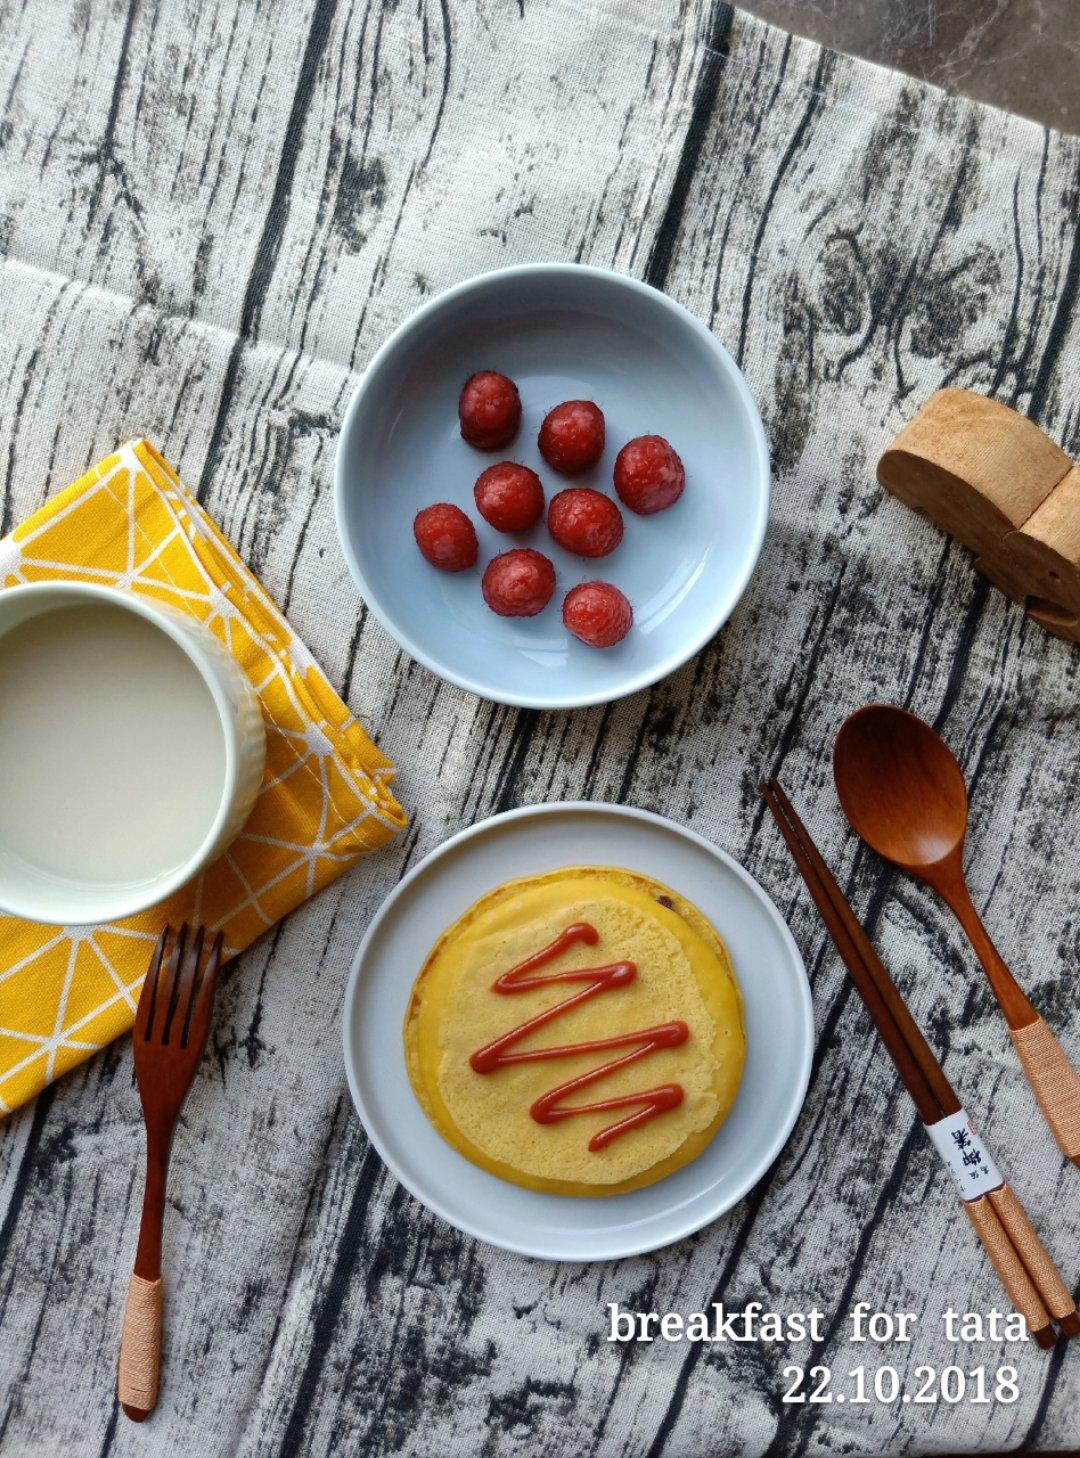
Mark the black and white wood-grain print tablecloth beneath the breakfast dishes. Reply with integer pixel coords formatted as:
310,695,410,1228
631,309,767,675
0,0,1080,1458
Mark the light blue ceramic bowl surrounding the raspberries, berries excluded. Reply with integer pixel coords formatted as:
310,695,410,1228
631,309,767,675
334,264,770,709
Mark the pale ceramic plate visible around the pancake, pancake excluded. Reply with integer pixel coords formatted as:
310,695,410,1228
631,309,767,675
344,803,813,1261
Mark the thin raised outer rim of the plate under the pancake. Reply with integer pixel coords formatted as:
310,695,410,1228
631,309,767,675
341,800,815,1264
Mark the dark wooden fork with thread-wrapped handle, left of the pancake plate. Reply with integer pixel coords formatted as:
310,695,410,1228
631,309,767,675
117,923,222,1423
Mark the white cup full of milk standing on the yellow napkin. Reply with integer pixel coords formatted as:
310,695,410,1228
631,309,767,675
0,582,267,926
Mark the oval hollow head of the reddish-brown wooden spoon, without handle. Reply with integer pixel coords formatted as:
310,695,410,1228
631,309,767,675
832,704,968,879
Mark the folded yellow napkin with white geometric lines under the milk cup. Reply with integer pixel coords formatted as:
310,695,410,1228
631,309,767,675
0,440,405,1114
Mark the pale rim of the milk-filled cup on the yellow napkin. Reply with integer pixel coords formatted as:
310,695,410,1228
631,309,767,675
0,577,240,926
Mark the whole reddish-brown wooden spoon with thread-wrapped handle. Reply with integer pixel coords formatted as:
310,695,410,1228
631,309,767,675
832,704,1080,1165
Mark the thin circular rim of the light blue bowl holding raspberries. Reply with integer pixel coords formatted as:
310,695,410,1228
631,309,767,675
334,262,772,710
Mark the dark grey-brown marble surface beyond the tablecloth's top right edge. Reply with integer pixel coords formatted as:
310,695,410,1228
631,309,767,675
739,0,1080,133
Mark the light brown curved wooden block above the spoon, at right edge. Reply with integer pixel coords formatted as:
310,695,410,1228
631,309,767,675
877,388,1080,643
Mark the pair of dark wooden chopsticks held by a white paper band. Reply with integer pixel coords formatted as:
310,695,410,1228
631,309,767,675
761,780,1080,1347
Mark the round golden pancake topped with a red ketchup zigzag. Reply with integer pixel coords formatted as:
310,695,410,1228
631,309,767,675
405,866,746,1196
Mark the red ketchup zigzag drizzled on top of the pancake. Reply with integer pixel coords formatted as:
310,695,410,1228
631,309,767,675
469,921,689,1153
